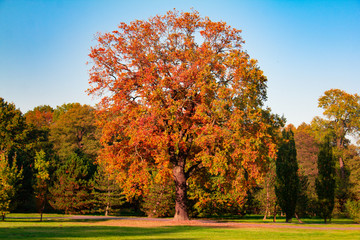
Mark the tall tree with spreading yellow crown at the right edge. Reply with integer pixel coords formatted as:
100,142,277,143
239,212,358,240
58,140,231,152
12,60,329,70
319,89,360,212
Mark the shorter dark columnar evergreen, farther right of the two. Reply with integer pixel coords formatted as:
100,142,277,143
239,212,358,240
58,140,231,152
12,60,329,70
316,139,335,223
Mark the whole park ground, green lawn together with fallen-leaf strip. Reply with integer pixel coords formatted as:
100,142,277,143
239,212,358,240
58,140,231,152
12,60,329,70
0,214,360,240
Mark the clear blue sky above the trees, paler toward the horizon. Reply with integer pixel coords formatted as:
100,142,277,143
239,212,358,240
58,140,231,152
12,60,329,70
0,0,360,126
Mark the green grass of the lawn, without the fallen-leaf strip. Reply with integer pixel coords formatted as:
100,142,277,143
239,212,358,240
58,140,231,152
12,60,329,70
0,214,360,240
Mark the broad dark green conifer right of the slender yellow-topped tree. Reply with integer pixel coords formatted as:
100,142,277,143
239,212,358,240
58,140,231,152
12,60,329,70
49,152,94,213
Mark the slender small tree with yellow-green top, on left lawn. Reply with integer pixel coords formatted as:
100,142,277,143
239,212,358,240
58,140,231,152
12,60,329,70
33,150,50,221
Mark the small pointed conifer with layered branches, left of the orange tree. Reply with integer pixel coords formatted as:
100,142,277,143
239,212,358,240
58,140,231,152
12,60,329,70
93,166,125,216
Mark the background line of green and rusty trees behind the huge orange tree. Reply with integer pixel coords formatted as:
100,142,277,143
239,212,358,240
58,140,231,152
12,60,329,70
0,89,360,221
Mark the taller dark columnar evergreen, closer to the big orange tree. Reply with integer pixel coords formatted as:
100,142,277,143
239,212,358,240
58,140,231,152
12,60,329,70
275,129,299,222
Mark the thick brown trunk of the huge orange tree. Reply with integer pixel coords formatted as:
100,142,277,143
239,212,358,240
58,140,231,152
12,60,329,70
173,163,189,221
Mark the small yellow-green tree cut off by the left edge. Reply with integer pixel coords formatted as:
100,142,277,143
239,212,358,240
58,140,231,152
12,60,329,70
0,152,22,221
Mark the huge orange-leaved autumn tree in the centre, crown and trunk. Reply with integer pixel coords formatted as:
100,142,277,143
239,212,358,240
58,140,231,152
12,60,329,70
89,11,280,220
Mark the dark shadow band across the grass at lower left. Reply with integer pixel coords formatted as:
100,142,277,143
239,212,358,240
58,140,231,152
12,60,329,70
0,225,197,240
